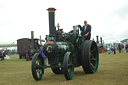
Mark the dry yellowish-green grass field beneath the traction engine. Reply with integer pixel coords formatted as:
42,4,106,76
0,53,128,85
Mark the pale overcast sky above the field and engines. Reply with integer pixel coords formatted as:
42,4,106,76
0,0,128,43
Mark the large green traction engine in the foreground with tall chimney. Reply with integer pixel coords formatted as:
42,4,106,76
31,8,99,81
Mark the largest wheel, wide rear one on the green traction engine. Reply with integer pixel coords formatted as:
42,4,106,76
81,40,99,74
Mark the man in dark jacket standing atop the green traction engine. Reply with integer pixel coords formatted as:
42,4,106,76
83,20,91,40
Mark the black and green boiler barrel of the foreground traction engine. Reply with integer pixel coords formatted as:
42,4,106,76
43,41,74,58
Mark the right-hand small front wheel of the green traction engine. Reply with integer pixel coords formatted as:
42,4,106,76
63,52,74,80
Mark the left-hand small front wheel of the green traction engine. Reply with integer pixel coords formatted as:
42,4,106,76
31,53,44,81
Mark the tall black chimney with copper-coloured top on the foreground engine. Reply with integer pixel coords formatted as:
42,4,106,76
47,8,56,37
